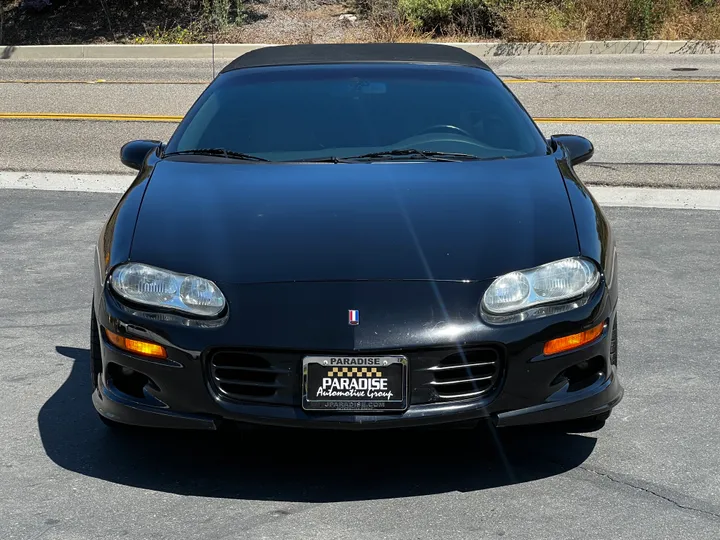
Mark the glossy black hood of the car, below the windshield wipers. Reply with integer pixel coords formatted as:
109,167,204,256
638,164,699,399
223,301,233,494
130,156,579,283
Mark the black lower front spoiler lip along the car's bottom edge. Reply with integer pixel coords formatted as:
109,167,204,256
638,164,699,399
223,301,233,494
93,366,623,431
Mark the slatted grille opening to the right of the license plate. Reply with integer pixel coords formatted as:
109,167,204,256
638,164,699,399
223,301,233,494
430,349,501,399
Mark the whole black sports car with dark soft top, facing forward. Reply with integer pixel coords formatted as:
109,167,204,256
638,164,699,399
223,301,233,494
91,44,623,429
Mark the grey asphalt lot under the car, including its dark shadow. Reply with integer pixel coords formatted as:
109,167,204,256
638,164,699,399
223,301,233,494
0,190,720,540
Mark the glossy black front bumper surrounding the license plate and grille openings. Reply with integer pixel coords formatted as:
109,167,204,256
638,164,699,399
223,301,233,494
93,282,623,430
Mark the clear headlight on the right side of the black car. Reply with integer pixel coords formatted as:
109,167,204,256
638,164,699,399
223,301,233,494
482,257,600,316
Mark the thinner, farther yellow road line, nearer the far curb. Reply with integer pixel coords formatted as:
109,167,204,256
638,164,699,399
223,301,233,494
0,77,720,85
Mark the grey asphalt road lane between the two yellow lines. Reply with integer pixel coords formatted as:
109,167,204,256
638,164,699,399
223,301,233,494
0,76,720,118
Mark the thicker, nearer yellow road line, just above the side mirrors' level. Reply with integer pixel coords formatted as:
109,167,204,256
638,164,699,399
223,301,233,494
0,112,720,124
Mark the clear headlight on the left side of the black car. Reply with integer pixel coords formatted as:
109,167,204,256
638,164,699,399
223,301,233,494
111,263,225,317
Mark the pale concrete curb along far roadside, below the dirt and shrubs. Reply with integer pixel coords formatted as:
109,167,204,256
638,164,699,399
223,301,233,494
0,40,720,60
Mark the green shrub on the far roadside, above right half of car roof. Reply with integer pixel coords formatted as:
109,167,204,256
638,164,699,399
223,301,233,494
398,0,503,37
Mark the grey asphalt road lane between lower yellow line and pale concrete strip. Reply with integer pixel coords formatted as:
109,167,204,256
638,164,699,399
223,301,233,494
0,120,720,189
